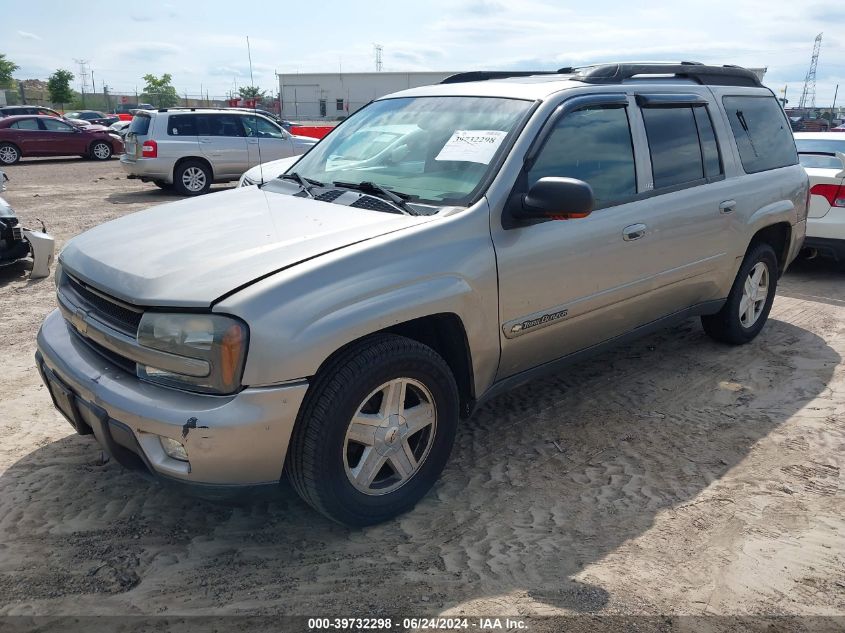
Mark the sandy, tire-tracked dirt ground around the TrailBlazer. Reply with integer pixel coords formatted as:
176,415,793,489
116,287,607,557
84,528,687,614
0,159,845,615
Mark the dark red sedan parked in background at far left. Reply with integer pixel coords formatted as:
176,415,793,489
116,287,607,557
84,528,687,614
0,115,123,165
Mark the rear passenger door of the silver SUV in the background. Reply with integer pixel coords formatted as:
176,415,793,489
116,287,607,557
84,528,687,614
196,113,250,180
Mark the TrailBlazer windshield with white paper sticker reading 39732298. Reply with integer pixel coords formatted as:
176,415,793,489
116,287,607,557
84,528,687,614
292,97,531,205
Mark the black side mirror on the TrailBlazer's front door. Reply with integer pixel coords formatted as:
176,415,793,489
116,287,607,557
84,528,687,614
511,176,595,220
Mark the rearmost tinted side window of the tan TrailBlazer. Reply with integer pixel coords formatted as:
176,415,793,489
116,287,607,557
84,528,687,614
722,97,798,174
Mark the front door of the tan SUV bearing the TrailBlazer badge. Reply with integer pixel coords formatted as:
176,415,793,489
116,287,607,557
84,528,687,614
493,94,657,379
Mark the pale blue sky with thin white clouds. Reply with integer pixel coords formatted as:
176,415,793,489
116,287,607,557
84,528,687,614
0,0,845,106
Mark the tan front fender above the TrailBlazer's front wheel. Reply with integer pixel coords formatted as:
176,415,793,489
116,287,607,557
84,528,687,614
214,201,499,393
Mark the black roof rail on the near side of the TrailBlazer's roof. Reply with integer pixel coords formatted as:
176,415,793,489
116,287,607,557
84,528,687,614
572,62,762,86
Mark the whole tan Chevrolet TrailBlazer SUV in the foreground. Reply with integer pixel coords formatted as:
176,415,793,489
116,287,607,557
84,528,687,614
36,63,809,525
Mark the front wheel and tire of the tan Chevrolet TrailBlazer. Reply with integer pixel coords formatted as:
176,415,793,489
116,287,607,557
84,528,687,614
285,334,458,526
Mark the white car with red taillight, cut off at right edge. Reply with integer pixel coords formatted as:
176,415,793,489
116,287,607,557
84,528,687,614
795,132,845,262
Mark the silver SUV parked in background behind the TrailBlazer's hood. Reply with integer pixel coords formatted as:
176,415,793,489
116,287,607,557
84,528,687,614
120,108,317,196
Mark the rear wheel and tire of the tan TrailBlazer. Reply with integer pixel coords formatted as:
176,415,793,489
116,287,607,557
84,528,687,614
701,242,778,345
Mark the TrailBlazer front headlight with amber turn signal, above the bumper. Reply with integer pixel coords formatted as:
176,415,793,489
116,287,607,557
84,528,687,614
137,312,249,394
